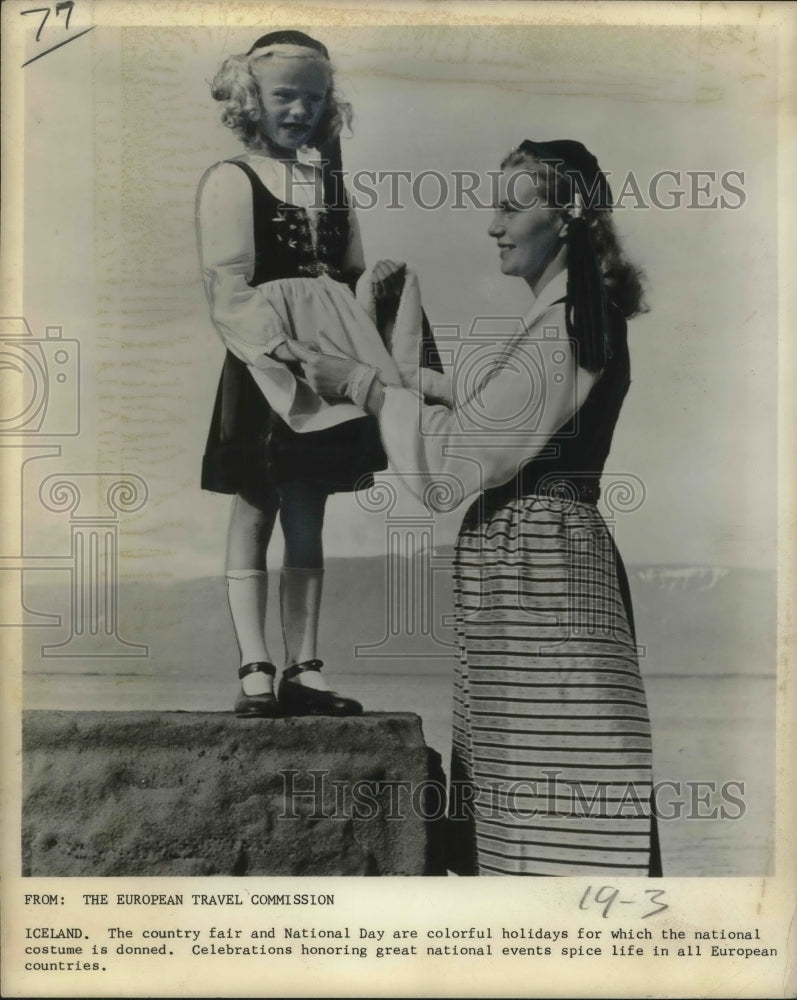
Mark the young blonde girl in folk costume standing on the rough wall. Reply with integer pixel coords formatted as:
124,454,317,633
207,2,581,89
197,31,386,717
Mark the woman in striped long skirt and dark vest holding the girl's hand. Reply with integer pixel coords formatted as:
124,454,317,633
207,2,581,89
295,140,659,875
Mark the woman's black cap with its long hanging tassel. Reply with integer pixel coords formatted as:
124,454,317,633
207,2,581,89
518,139,612,372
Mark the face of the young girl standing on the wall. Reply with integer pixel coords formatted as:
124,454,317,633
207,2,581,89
252,50,330,153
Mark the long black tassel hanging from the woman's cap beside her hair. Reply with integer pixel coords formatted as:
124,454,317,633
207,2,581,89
566,216,611,372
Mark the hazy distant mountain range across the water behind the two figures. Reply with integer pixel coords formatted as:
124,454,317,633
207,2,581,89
22,551,776,677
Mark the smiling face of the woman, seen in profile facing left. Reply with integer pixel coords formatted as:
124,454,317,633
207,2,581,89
487,165,564,285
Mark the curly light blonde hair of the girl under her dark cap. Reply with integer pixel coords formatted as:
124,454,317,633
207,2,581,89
210,42,353,149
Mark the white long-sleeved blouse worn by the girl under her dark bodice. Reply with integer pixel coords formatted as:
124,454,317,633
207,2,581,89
196,154,365,370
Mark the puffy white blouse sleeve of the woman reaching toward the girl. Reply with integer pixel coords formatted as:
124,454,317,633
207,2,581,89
379,305,600,510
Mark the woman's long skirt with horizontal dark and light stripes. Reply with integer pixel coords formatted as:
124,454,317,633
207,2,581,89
448,496,657,875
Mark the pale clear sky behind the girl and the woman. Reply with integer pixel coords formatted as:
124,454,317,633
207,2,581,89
12,19,778,580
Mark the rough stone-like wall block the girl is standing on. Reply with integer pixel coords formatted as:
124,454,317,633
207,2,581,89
22,711,445,876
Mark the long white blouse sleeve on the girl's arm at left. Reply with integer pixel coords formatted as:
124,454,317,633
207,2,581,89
196,163,286,367
